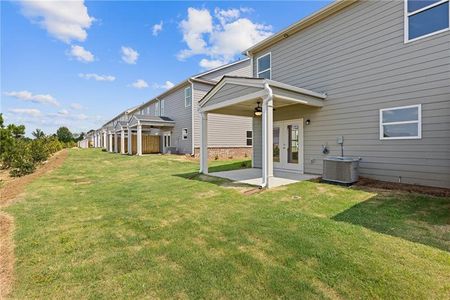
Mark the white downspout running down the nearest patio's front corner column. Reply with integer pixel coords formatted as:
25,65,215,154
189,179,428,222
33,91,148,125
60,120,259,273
261,82,273,188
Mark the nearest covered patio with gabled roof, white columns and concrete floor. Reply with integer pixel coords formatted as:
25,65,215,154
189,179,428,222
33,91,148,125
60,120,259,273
199,76,326,188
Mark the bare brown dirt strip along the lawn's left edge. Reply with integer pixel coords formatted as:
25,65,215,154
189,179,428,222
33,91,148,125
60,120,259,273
0,150,67,299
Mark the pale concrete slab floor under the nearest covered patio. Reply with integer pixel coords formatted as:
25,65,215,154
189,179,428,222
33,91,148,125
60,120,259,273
209,168,320,187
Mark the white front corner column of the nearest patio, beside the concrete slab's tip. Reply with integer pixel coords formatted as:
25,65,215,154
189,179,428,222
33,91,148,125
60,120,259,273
262,83,273,188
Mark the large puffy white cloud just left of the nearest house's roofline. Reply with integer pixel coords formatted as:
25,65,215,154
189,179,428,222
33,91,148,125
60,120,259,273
177,7,272,69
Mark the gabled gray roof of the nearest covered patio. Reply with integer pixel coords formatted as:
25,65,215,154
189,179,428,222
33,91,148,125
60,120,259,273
199,76,327,116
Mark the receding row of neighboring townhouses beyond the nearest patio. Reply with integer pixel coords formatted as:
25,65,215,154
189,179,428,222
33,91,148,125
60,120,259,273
98,58,252,158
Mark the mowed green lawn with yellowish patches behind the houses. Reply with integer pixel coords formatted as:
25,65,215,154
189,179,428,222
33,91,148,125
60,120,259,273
5,149,450,299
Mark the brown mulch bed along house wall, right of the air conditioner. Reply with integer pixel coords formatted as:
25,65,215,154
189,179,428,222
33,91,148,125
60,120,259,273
354,177,450,197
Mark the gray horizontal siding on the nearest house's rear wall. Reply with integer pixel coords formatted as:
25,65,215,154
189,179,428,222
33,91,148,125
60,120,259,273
254,1,450,187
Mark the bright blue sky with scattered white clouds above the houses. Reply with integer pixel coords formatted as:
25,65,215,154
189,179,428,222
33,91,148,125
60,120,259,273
0,0,329,135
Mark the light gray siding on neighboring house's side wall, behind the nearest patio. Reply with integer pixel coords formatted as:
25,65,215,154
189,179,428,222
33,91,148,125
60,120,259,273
194,83,252,147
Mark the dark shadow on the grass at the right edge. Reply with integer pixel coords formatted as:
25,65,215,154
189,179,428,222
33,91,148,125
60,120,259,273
332,191,450,252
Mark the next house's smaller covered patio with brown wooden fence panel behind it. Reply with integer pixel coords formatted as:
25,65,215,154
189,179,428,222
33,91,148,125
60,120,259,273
128,115,175,155
